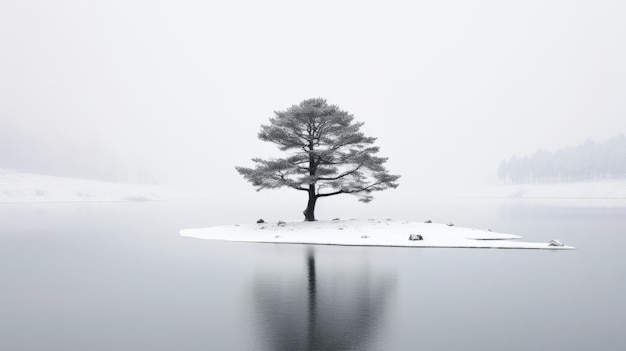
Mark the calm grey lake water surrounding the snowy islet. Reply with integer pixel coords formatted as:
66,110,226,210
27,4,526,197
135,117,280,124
0,200,626,350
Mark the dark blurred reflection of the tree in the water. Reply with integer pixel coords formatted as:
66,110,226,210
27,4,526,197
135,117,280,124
253,248,396,350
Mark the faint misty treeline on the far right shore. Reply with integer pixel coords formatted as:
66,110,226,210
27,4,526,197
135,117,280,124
498,135,626,183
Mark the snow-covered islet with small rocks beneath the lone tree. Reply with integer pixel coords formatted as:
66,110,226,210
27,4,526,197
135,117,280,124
180,219,574,250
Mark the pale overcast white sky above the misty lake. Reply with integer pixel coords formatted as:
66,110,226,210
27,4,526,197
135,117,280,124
0,0,626,198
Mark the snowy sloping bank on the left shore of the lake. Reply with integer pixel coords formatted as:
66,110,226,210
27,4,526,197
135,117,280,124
0,169,181,203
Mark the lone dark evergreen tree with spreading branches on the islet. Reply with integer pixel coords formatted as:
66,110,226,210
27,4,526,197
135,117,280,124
235,98,400,221
